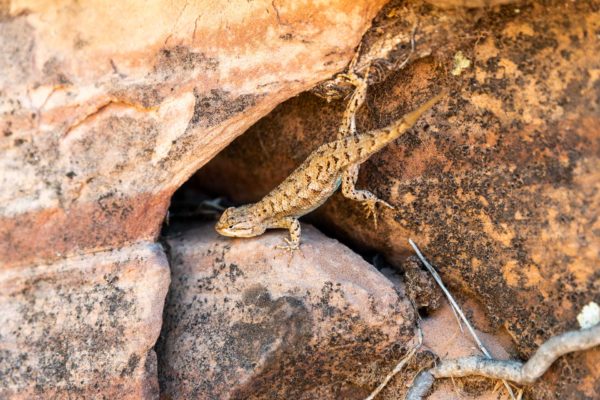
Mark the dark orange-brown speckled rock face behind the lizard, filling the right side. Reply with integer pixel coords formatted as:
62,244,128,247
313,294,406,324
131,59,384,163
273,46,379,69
198,2,600,399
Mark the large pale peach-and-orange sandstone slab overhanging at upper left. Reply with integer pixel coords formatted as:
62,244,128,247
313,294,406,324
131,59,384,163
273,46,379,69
0,0,384,267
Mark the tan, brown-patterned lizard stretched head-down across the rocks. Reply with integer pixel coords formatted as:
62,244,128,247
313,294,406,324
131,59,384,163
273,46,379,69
215,74,445,251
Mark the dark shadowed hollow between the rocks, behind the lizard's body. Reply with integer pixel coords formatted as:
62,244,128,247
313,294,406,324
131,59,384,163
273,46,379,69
163,89,390,269
